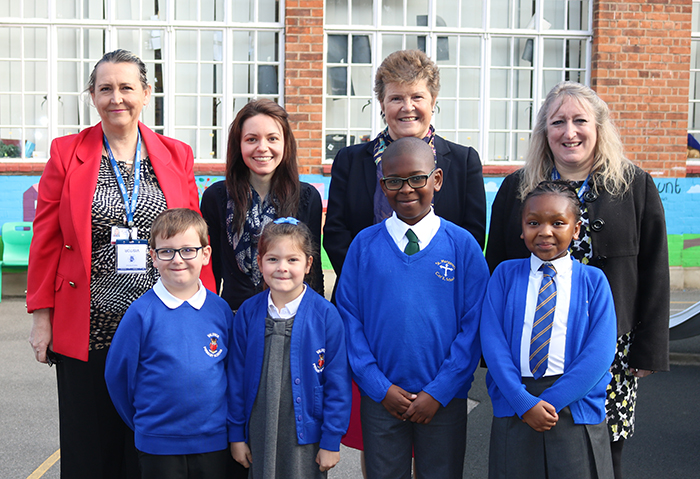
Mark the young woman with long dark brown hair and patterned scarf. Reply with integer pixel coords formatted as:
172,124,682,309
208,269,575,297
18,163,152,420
201,99,323,311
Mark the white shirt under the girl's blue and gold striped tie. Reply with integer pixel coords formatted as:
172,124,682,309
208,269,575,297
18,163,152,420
520,254,573,378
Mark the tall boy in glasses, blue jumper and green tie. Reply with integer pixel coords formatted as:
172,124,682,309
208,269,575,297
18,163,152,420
336,138,489,479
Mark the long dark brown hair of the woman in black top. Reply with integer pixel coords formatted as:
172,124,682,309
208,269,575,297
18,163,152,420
226,99,299,228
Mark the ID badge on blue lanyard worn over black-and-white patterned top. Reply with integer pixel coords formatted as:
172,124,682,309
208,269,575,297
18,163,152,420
104,131,148,274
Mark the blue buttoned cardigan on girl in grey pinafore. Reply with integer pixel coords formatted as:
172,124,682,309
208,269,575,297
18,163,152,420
228,285,351,451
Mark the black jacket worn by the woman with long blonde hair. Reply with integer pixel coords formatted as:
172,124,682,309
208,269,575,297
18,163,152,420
486,167,671,371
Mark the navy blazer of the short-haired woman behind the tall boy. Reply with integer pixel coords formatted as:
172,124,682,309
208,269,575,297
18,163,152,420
323,135,486,275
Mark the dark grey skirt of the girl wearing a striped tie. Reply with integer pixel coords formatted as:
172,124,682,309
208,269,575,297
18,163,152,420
489,376,613,479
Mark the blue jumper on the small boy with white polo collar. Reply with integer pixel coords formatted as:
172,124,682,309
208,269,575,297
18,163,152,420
105,289,233,455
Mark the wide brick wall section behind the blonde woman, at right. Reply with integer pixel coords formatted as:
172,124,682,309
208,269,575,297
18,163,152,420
591,0,692,177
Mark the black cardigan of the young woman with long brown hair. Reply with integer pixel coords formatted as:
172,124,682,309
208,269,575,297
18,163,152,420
200,181,323,311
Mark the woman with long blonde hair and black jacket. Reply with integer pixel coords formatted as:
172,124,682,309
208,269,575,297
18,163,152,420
486,82,670,479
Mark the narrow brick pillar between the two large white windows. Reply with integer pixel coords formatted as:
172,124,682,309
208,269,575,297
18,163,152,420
284,0,323,174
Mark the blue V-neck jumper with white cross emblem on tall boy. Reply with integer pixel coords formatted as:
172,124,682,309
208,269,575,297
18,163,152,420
336,218,489,406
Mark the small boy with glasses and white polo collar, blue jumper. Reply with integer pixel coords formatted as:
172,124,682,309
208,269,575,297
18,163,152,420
105,208,233,479
